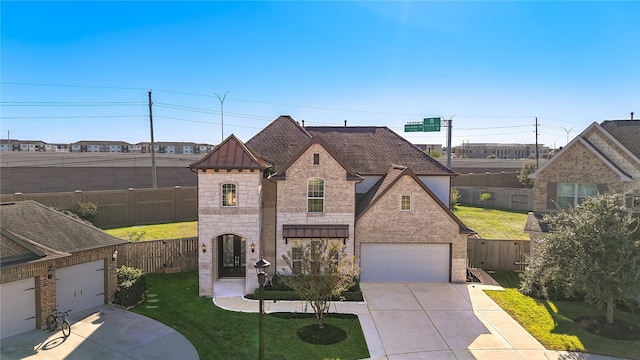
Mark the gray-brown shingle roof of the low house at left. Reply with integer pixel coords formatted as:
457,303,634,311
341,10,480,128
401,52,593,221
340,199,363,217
0,200,127,253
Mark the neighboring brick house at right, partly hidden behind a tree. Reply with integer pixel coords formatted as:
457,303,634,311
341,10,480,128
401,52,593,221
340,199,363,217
525,120,640,245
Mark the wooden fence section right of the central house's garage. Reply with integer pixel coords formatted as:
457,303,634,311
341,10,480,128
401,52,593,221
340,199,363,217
467,238,531,271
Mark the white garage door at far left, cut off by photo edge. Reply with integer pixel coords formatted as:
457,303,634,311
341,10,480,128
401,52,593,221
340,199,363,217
0,278,36,338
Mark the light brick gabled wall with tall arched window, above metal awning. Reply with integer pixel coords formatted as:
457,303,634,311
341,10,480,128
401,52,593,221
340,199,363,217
275,144,355,272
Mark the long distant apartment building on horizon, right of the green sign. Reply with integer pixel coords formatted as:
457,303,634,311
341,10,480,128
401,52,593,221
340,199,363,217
454,143,551,159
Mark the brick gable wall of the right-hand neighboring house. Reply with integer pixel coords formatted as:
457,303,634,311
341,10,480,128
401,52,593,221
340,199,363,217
533,135,640,212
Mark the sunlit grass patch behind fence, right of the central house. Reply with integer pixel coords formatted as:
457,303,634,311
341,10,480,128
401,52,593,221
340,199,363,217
454,205,529,240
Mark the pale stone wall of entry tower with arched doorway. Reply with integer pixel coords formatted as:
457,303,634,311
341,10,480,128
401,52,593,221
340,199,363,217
198,169,262,296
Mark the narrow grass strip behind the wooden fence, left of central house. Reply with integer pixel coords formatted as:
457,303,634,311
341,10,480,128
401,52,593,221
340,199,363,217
105,221,198,240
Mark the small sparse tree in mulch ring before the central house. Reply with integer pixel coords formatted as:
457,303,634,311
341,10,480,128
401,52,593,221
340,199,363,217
282,240,360,329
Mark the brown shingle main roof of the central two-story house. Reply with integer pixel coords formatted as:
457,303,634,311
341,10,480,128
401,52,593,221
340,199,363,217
246,116,456,176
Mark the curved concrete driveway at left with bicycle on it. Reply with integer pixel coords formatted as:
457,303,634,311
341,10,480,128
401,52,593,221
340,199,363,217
0,305,198,360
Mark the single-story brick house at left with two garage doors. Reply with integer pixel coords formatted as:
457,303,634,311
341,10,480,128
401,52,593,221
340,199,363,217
0,200,127,338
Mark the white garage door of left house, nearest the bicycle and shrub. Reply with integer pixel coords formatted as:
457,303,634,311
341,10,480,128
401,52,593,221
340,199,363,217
56,260,104,312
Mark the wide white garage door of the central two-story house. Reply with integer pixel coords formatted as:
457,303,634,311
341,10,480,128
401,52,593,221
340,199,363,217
360,243,451,282
